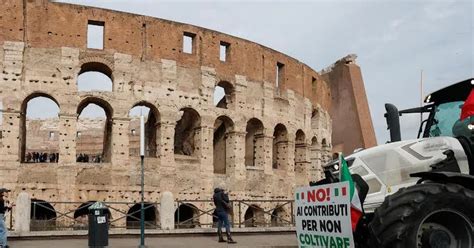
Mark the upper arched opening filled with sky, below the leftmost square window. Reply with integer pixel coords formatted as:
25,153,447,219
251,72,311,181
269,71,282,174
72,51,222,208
77,62,113,91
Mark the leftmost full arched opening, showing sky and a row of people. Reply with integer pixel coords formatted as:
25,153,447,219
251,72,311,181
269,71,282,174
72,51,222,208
20,93,59,163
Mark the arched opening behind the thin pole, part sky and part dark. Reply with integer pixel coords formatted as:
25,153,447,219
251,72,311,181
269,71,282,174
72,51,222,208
129,102,159,157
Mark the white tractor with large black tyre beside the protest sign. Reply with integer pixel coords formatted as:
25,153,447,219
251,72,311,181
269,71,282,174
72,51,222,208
317,79,474,248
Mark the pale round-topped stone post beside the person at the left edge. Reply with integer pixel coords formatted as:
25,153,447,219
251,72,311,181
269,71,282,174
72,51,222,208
14,192,31,234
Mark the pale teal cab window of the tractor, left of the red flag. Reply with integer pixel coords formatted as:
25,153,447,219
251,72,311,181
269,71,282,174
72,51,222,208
430,101,464,137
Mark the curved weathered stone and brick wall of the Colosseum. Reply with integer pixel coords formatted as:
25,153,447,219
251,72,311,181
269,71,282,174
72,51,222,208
0,0,331,229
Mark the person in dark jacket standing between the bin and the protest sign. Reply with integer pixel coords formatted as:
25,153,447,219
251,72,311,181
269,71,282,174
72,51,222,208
212,188,237,244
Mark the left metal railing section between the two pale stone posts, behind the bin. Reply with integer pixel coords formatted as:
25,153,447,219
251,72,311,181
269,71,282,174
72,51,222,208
30,201,160,231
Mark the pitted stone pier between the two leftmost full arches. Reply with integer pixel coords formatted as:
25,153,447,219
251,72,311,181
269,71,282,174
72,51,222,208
59,113,77,164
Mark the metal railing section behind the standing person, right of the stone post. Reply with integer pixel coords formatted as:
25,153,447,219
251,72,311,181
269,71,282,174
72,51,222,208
175,200,295,228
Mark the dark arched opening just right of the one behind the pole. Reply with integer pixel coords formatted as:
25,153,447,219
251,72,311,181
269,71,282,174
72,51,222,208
174,108,201,156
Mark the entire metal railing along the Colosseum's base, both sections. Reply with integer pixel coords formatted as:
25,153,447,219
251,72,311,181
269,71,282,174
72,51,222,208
30,200,295,231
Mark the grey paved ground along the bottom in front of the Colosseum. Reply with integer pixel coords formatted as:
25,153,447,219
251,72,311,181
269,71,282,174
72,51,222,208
9,233,297,248
